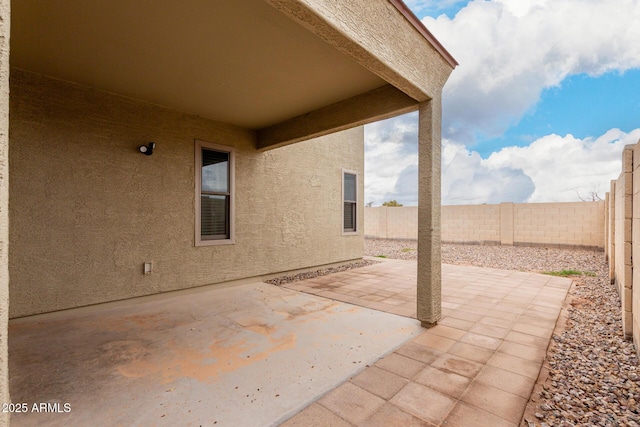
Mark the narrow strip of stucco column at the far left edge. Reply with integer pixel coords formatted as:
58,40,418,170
0,0,11,426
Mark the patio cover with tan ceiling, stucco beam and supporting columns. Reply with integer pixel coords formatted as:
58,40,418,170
0,0,456,418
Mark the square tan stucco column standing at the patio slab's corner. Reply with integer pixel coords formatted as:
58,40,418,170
418,97,442,327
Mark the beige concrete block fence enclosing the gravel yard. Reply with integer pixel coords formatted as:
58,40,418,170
364,134,640,356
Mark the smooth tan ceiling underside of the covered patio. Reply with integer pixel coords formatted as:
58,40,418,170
11,0,448,148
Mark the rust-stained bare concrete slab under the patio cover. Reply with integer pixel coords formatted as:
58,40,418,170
9,283,423,426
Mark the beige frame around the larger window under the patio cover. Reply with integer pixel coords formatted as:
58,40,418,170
194,139,236,246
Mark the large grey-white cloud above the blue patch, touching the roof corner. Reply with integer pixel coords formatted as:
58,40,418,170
423,0,640,144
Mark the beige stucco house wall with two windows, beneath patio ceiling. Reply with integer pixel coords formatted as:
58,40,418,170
9,70,364,317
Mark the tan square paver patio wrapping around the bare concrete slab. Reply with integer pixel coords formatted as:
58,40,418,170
283,260,571,427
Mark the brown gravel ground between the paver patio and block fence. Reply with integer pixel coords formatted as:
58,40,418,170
365,239,640,427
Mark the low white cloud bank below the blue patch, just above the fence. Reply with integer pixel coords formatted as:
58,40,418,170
365,124,640,206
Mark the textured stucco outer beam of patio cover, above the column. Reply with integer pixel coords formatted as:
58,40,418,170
267,0,453,101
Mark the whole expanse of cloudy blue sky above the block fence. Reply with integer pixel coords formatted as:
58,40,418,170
365,0,640,206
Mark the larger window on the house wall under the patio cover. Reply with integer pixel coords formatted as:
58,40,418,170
196,141,235,246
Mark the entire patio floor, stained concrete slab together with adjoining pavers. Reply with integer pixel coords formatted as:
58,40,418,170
9,260,571,427
